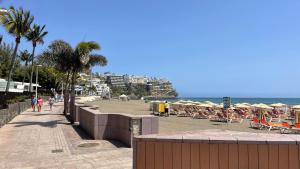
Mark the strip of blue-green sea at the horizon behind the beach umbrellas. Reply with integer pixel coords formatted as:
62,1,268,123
168,97,300,105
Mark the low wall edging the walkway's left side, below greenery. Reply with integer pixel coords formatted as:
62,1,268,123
0,100,31,127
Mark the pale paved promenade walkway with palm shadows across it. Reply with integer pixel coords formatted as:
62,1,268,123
0,103,132,169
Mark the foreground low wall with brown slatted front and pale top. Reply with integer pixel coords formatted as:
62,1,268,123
133,130,300,169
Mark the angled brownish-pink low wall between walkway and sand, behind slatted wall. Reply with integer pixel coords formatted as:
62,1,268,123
79,107,158,147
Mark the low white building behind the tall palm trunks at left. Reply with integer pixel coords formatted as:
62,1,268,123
0,79,41,93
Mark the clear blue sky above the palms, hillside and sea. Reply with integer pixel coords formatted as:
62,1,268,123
0,0,300,97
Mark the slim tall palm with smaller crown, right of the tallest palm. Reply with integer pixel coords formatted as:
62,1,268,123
26,24,48,92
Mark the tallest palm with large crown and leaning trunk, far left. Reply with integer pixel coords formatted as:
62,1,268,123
0,7,34,93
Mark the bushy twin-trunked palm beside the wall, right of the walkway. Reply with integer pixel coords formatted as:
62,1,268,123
40,41,107,119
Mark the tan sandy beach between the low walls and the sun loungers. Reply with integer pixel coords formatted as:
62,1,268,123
82,100,279,133
